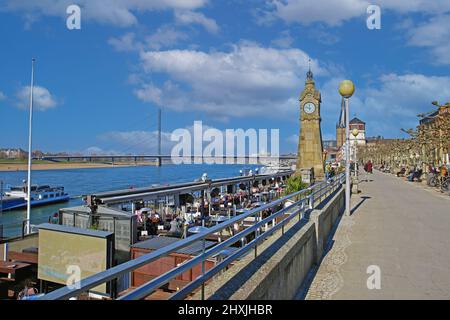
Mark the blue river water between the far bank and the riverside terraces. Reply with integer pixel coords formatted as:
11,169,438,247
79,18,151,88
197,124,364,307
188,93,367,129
0,164,256,237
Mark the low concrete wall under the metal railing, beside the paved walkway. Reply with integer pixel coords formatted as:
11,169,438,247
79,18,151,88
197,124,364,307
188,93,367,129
193,188,345,300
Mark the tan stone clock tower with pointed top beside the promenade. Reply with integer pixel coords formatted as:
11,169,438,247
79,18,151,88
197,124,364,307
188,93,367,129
297,69,325,180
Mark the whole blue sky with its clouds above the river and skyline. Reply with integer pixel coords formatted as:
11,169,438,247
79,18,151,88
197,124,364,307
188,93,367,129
0,0,450,153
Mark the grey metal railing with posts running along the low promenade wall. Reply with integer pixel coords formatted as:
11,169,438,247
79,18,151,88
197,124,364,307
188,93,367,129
39,174,345,300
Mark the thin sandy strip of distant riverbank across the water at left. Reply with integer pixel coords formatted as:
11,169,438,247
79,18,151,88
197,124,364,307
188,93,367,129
0,161,156,172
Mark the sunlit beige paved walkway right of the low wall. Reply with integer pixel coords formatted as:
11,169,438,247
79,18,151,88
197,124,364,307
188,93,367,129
306,172,450,299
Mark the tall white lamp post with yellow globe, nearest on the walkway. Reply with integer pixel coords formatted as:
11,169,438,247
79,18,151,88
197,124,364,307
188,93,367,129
339,80,355,216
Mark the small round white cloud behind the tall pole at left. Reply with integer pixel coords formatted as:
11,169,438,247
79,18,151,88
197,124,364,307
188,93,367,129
16,86,58,111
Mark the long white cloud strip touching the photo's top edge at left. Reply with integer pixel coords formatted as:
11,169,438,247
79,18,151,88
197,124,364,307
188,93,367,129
0,0,208,27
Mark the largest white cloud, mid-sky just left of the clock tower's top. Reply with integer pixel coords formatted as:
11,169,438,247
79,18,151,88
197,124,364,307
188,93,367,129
135,42,327,120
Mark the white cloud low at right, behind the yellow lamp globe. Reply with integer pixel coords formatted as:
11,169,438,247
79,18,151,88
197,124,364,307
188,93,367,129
321,74,450,137
